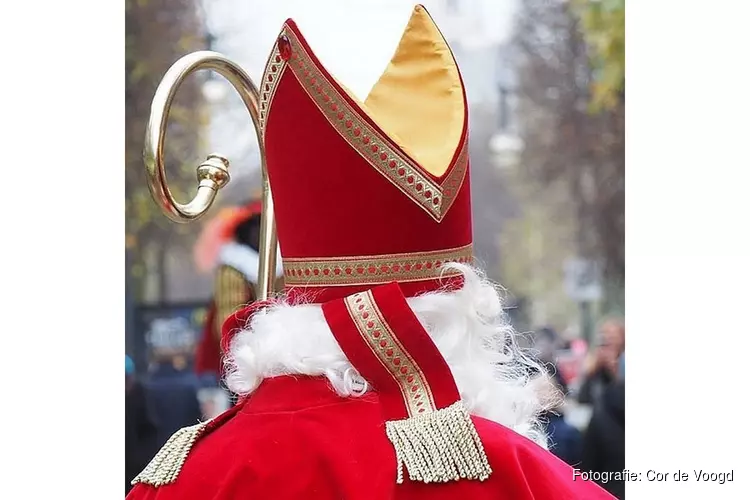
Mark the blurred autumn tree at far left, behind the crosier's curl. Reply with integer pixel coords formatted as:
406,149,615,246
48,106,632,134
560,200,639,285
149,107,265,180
125,0,208,302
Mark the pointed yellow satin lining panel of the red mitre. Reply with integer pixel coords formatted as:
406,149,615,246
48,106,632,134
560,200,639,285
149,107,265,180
364,5,465,177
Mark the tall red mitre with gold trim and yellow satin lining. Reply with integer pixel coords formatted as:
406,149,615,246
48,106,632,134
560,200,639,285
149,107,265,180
260,6,472,303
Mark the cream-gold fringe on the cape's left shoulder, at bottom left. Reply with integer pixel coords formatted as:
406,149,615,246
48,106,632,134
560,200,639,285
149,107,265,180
131,420,210,488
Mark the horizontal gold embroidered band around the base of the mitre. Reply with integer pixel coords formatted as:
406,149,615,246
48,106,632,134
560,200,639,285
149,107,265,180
284,244,473,287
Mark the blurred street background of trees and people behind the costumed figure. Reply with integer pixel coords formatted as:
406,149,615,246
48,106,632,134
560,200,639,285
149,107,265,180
125,0,625,498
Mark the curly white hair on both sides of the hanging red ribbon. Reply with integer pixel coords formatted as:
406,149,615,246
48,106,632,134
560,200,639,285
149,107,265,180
225,264,546,446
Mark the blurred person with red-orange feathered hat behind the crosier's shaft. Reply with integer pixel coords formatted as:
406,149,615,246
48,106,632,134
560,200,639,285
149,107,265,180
194,200,281,383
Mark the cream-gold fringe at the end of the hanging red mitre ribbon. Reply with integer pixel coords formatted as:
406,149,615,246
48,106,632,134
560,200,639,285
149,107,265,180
386,401,492,484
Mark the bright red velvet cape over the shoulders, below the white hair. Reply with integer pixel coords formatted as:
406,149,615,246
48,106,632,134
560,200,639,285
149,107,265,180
127,377,613,500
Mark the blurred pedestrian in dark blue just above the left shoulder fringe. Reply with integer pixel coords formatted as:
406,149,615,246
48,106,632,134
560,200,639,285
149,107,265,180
139,350,202,450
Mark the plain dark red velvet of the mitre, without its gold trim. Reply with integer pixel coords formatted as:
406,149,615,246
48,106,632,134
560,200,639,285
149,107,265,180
264,20,472,302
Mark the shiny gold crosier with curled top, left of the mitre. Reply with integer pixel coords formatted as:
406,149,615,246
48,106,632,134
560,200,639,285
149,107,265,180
143,51,277,300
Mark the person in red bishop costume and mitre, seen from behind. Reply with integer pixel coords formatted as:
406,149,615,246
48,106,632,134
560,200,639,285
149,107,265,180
129,6,611,500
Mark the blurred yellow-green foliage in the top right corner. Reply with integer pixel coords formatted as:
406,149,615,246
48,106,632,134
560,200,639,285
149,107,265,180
574,0,625,111
